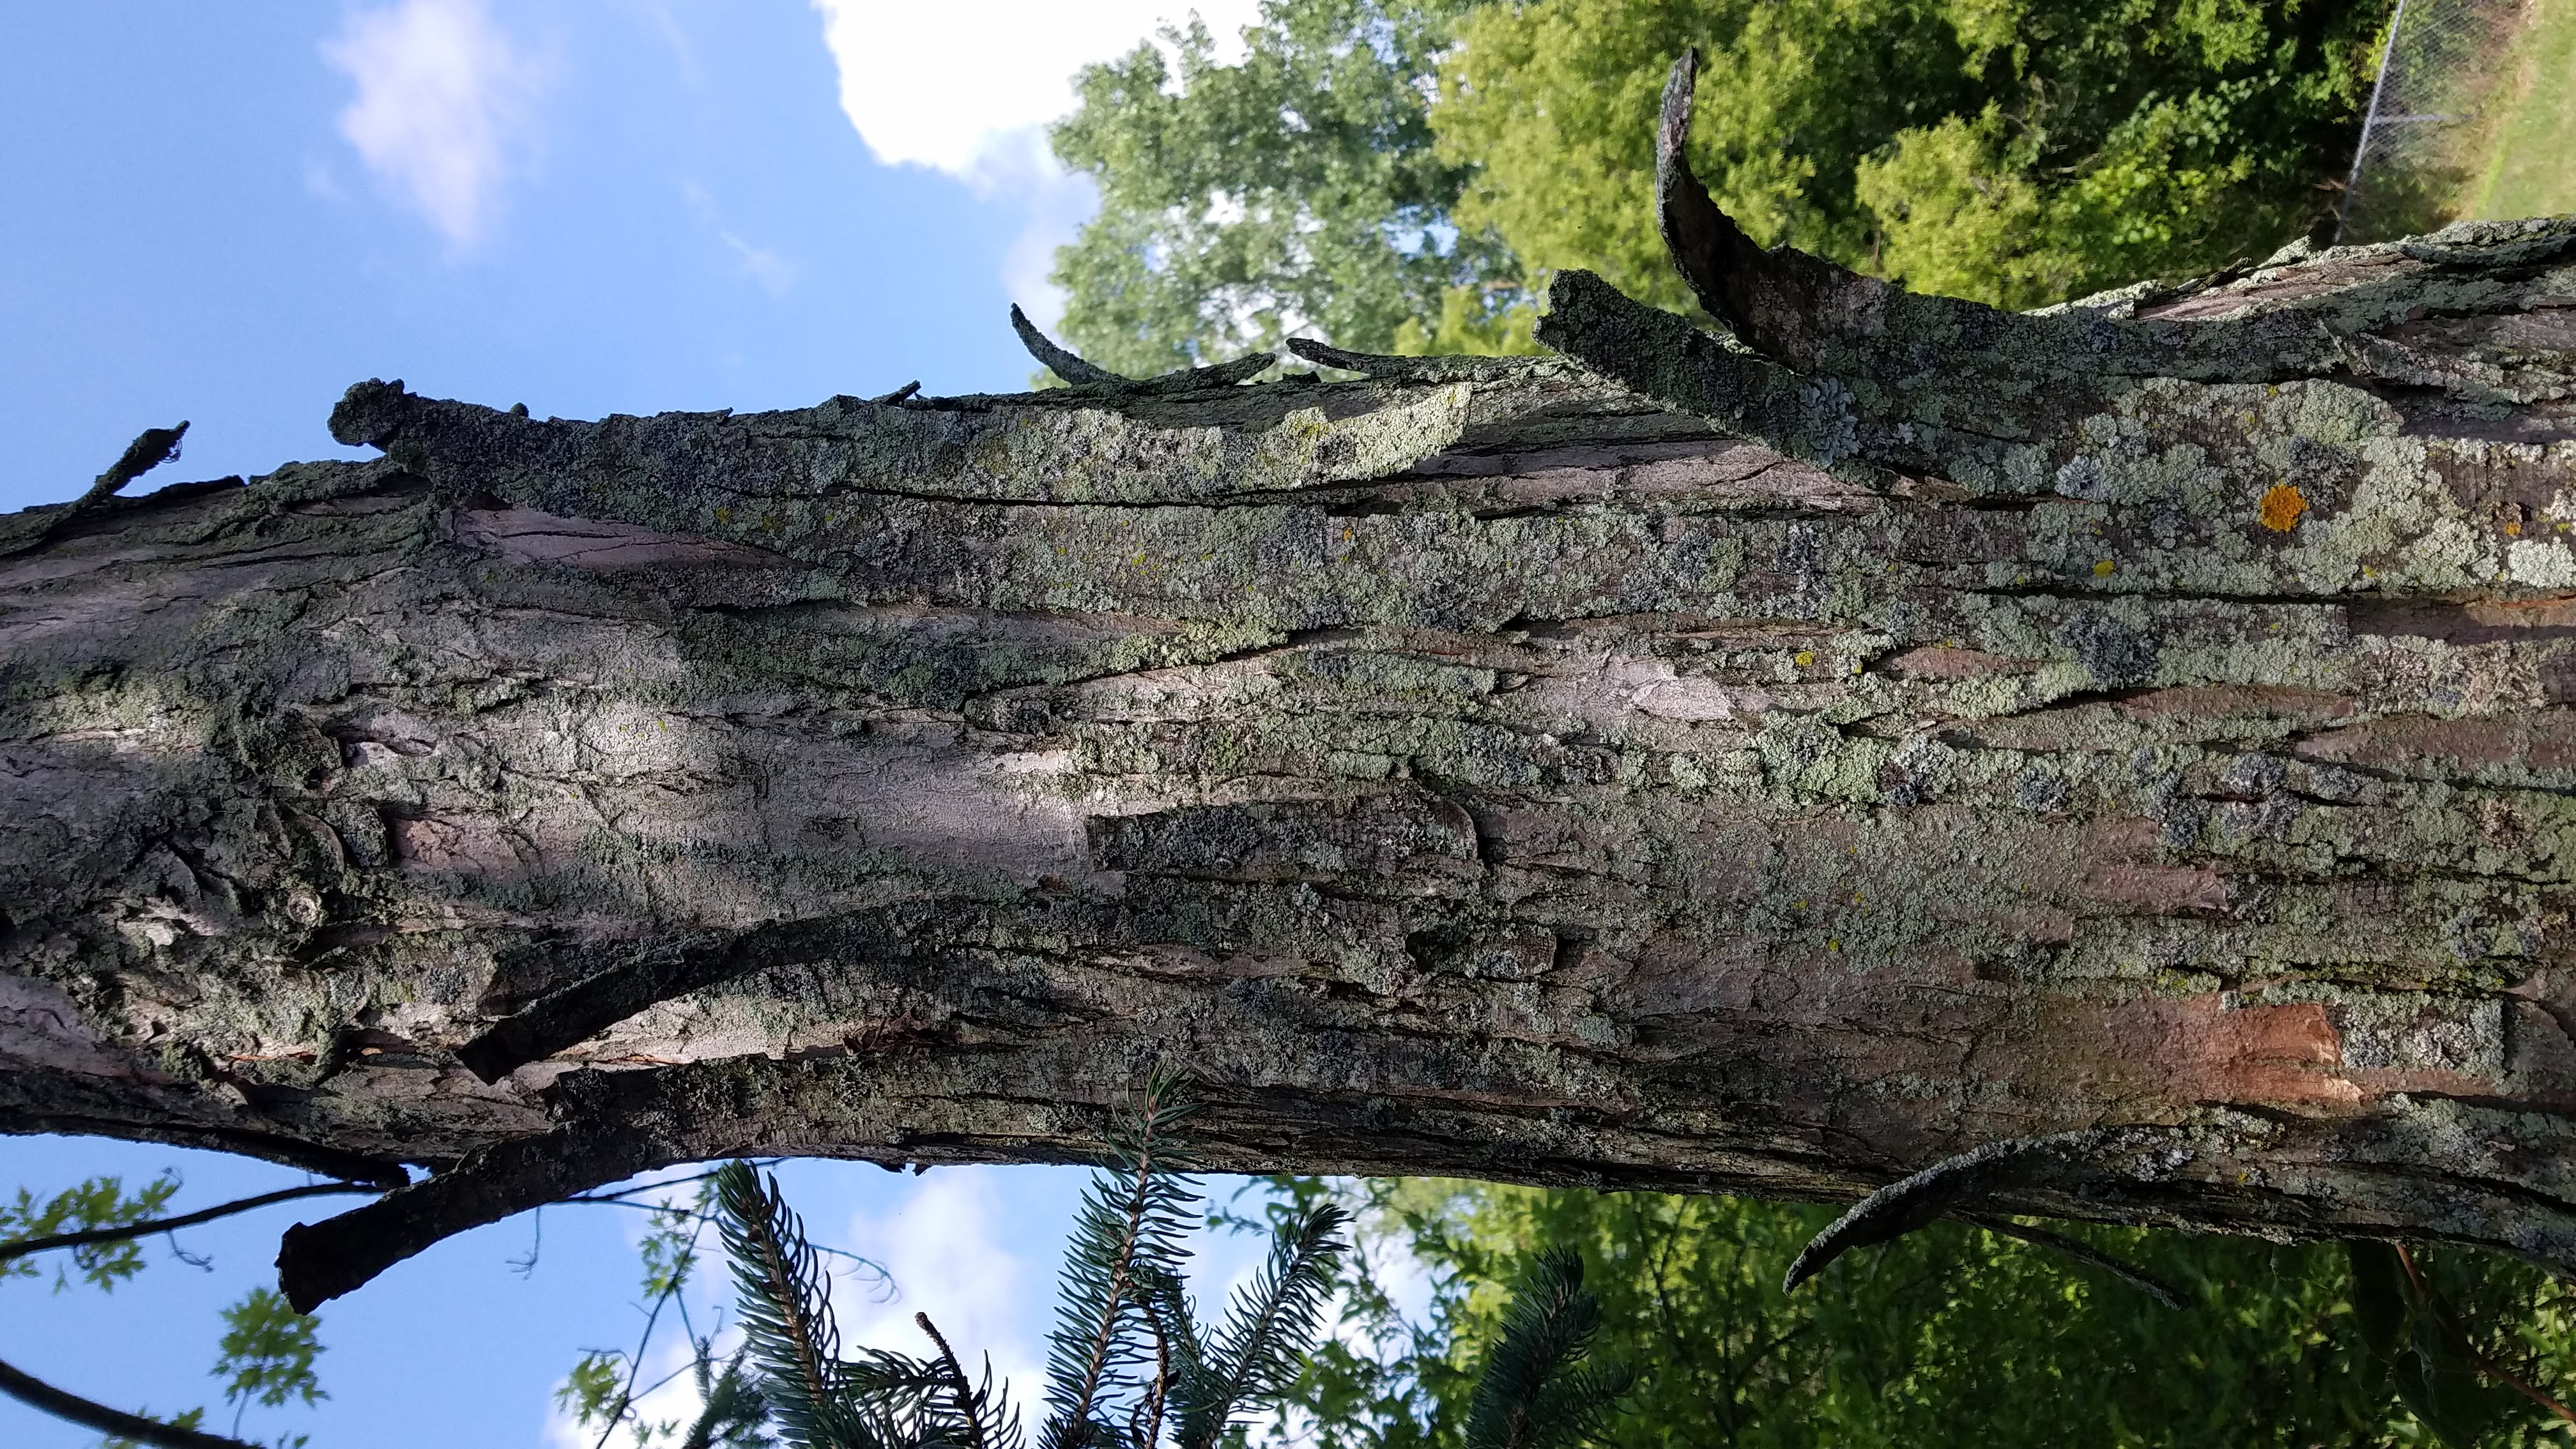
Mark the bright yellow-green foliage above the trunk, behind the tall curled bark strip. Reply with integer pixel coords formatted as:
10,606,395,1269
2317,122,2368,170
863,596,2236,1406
1432,0,2388,309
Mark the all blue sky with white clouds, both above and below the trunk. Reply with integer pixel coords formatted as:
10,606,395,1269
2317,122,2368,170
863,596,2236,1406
0,0,1308,1449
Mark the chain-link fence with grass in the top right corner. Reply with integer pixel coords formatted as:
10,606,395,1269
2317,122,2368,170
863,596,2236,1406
2336,0,2576,242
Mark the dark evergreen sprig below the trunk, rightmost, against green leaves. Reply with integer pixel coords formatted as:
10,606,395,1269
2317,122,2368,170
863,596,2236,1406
1466,1248,1636,1449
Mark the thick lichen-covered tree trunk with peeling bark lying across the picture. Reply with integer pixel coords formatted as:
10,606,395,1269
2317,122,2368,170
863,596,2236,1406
0,206,2576,1305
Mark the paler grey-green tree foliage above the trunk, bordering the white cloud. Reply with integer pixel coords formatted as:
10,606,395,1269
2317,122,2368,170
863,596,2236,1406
1054,0,1517,376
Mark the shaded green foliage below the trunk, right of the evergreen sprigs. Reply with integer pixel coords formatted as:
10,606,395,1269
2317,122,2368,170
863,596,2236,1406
1285,1178,2576,1449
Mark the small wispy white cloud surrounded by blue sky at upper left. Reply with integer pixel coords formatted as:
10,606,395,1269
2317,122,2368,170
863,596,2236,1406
322,0,546,247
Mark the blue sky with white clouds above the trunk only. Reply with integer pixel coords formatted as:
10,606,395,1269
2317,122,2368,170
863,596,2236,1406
0,0,1250,508
